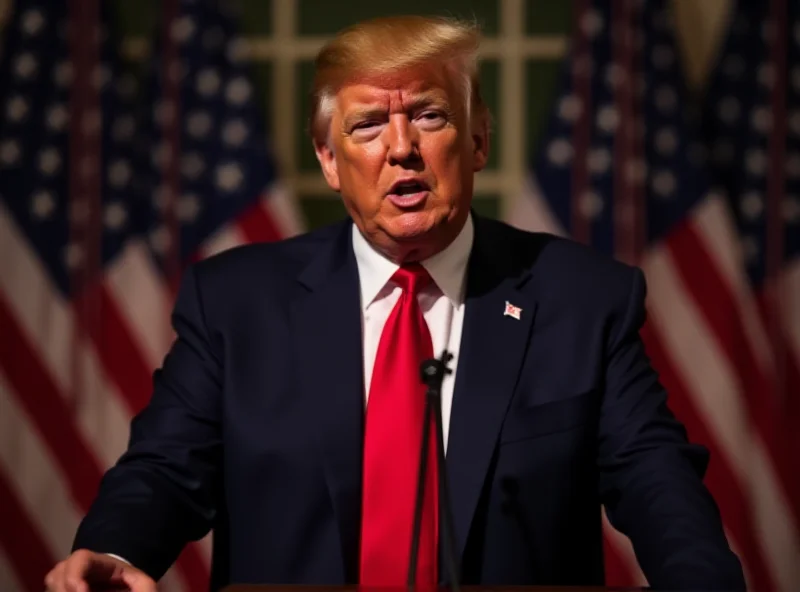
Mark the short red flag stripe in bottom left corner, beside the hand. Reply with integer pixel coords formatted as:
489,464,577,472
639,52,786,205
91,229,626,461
0,471,56,592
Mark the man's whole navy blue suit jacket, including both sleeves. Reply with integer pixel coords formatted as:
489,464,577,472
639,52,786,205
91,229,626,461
74,216,744,589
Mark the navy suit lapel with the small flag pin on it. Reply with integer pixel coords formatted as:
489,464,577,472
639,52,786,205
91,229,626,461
447,216,536,556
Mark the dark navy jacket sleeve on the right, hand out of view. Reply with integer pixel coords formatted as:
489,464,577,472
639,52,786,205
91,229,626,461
598,269,745,590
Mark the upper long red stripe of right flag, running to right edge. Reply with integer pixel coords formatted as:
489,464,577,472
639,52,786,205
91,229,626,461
666,221,800,530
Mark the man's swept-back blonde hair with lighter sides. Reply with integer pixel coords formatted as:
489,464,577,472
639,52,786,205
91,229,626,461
309,16,488,142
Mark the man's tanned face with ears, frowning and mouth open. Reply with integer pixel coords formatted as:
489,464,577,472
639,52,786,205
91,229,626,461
316,65,488,261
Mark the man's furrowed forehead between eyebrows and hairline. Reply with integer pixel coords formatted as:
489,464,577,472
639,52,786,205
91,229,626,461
336,66,461,112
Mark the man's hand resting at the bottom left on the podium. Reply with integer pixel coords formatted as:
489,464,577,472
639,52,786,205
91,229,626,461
44,549,156,592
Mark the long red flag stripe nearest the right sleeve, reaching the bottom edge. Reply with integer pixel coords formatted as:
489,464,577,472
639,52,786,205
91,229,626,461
642,322,775,591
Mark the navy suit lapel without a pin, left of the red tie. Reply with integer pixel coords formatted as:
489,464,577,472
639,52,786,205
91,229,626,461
291,224,364,582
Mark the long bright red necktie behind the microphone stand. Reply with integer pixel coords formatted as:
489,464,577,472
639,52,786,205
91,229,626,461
360,264,438,586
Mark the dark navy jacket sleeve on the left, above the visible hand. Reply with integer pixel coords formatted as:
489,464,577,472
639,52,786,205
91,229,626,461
73,268,222,579
